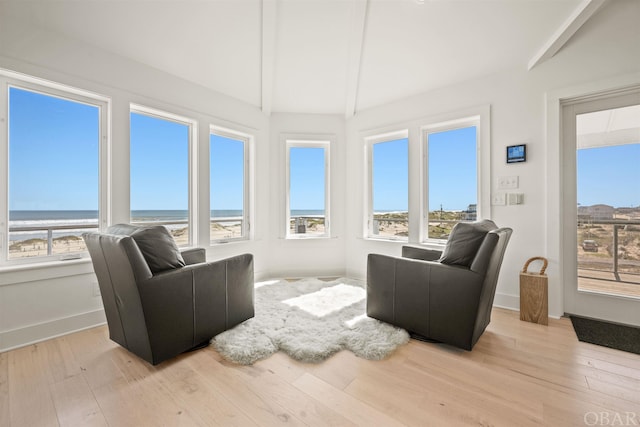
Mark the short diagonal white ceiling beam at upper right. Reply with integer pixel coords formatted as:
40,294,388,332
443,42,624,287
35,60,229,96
528,0,609,71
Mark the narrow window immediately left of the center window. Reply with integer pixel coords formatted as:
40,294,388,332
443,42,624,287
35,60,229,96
209,126,251,243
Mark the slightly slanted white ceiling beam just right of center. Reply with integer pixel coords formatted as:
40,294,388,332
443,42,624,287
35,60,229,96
345,0,368,118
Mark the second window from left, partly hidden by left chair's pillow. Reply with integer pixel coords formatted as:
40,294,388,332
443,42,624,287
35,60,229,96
130,106,196,246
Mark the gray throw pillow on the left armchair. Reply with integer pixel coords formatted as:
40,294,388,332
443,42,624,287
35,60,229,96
131,225,185,274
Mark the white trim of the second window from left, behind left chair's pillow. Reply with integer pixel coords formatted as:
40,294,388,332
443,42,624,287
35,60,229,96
129,103,198,247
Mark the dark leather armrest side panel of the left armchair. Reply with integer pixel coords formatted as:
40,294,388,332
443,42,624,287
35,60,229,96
138,254,254,360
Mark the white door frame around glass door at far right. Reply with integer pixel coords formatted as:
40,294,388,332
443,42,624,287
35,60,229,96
546,73,640,325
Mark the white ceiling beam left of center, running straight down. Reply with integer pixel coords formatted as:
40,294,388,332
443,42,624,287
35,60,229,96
260,0,278,116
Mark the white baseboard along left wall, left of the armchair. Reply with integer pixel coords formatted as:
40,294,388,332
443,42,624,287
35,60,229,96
0,309,106,352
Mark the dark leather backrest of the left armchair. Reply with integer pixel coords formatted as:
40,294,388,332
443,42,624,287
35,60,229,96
82,233,152,360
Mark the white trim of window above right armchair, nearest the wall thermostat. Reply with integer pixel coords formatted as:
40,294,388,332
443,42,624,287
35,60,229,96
419,105,491,249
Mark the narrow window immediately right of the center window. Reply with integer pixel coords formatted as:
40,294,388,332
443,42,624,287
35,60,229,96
366,131,409,241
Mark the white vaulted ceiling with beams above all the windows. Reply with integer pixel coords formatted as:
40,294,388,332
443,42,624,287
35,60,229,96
3,0,603,116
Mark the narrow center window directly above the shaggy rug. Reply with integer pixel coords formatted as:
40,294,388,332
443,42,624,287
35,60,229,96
286,140,330,238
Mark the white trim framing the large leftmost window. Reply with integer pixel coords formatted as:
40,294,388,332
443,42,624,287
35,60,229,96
0,72,111,266
